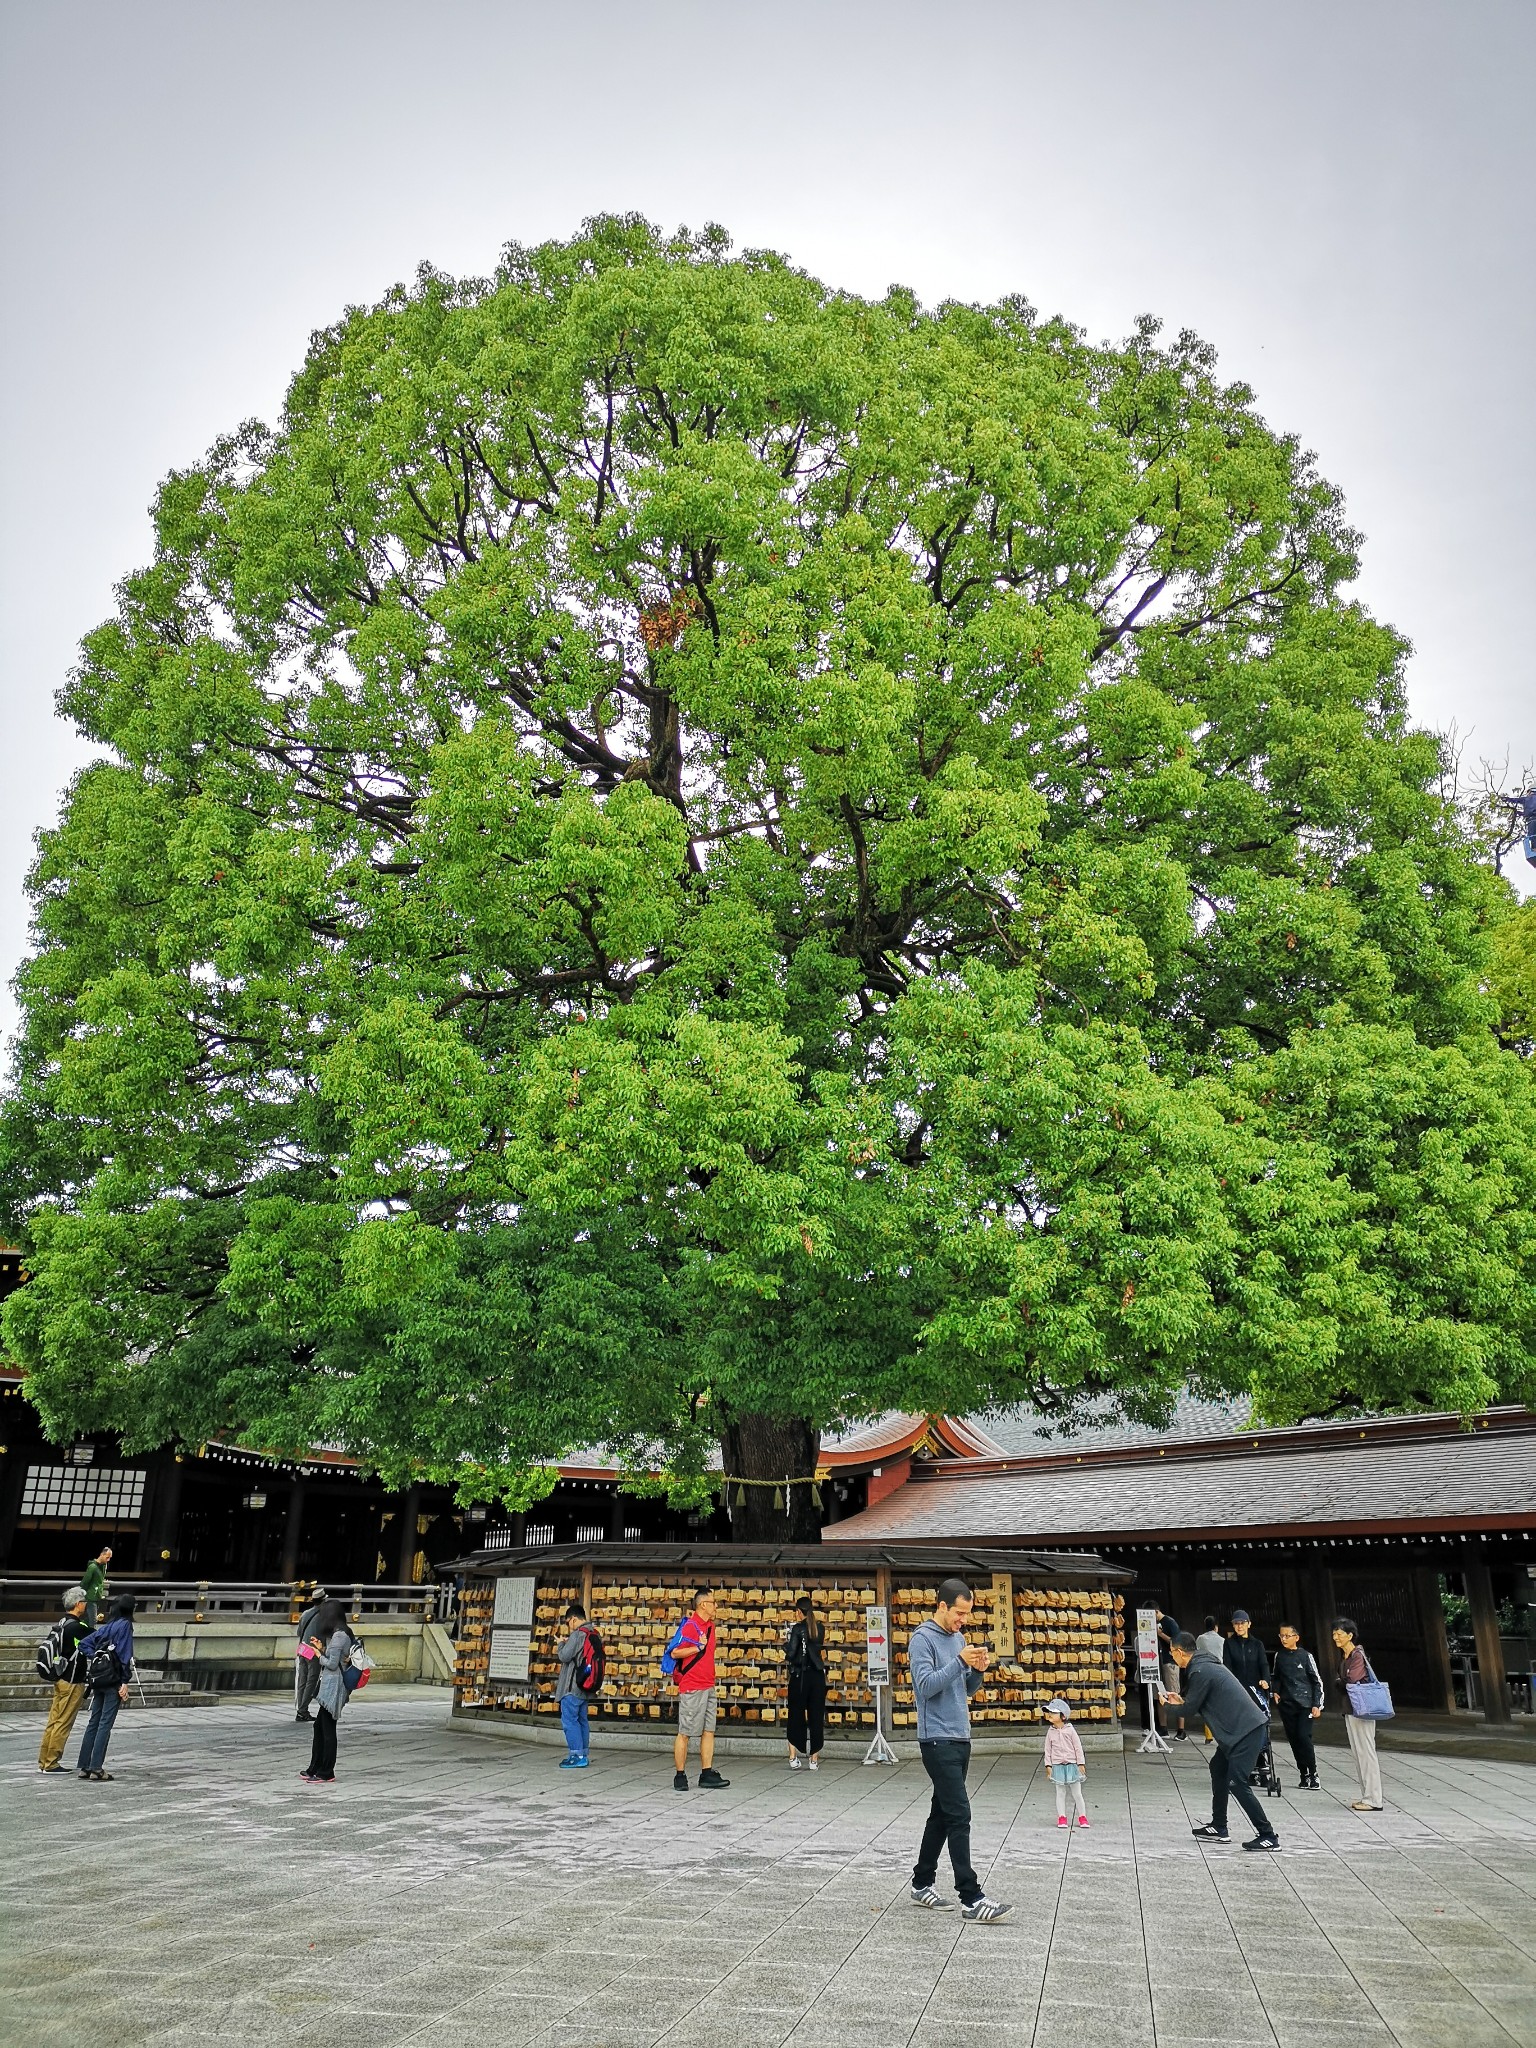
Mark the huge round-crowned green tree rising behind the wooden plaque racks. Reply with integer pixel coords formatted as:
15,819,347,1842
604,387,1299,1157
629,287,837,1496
0,219,1536,1534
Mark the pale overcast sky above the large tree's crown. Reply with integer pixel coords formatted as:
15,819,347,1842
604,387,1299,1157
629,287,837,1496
0,0,1536,1028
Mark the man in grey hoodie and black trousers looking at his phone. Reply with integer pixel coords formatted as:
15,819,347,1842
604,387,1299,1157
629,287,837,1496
907,1579,1014,1921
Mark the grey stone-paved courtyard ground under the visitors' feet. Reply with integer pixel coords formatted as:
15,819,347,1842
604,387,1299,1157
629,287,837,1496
0,1688,1536,2048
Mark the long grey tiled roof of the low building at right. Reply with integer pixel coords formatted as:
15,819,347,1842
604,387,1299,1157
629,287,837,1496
823,1430,1536,1544
